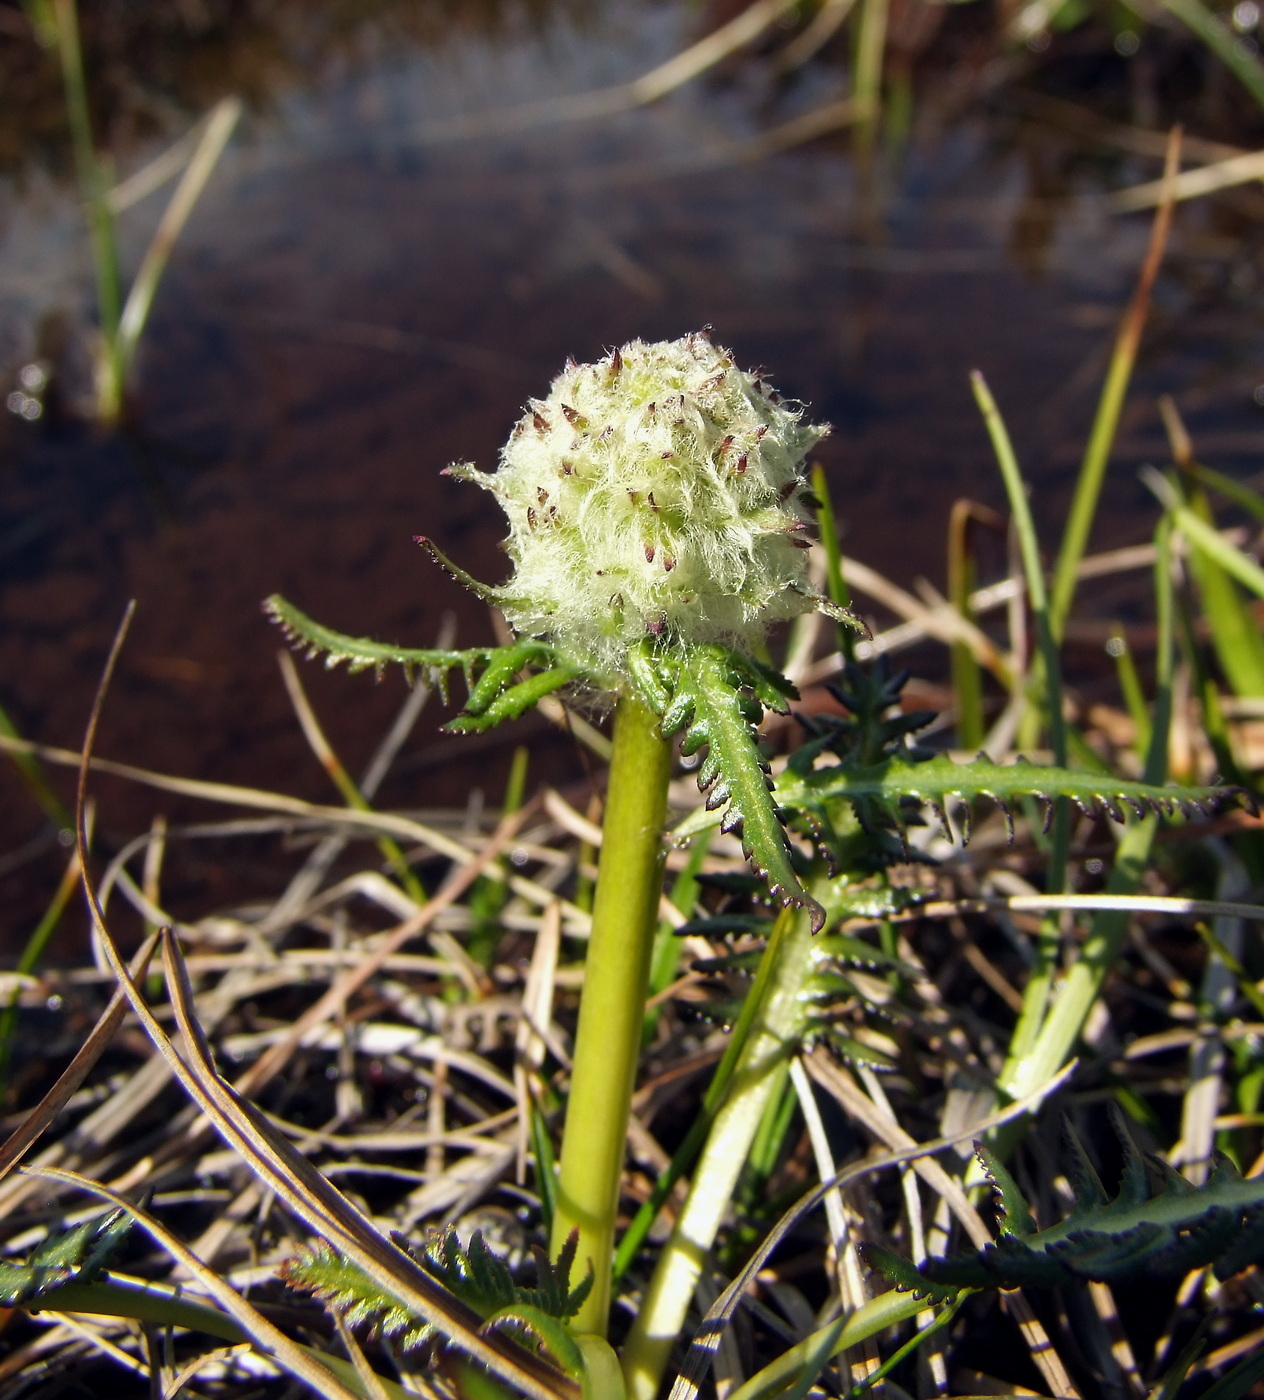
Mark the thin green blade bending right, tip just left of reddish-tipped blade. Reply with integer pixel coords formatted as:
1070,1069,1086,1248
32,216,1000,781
970,371,1069,1061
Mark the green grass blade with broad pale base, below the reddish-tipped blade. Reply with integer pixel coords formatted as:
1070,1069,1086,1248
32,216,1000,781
999,517,1174,1099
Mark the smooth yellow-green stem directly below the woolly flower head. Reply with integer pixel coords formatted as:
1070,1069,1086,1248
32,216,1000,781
553,697,672,1337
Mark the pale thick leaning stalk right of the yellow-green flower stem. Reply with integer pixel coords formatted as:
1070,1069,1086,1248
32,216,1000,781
623,910,813,1400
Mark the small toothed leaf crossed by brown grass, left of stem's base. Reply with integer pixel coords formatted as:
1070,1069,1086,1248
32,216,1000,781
281,1225,592,1351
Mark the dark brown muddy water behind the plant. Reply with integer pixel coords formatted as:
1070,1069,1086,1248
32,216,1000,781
0,0,1264,937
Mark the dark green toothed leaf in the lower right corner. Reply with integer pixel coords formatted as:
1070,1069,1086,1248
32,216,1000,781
869,1110,1264,1292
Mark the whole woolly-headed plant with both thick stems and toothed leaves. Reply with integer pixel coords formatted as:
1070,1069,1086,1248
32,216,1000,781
257,332,1226,1400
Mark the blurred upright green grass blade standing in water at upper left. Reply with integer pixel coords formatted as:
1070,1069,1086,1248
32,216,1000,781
52,0,123,423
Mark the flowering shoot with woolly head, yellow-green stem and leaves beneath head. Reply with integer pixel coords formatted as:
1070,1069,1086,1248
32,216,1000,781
269,332,854,1336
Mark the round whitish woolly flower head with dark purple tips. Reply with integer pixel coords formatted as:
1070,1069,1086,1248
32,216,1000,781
449,332,833,686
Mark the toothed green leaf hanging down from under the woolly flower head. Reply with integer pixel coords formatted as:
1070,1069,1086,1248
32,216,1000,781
659,645,824,932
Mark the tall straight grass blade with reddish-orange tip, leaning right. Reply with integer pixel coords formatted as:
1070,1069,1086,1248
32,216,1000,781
1050,126,1180,641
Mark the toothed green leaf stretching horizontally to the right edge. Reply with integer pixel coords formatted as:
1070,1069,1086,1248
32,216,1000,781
777,753,1251,840
